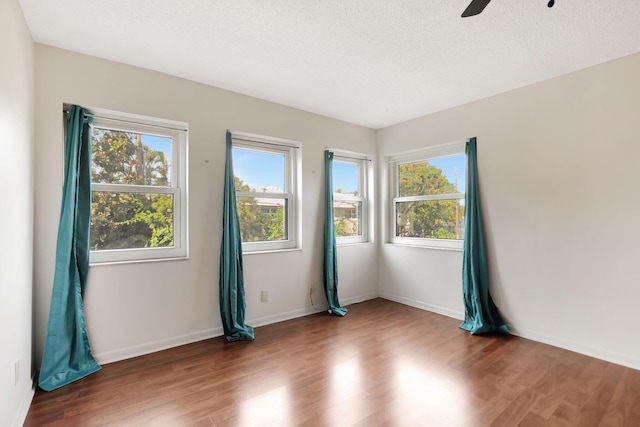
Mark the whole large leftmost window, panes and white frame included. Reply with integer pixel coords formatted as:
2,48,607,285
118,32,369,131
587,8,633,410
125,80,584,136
85,110,187,263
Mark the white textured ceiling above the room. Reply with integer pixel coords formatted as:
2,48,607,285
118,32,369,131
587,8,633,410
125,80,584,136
20,0,640,128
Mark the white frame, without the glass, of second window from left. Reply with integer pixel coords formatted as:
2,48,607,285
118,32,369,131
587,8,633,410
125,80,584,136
231,131,302,254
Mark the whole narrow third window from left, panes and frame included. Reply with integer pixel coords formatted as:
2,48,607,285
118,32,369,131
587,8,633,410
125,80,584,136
332,150,370,244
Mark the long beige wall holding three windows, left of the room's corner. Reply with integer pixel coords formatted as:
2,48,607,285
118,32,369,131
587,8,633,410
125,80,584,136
34,45,378,362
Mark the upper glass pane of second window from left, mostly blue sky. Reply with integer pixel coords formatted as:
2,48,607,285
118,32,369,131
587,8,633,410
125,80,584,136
233,148,285,193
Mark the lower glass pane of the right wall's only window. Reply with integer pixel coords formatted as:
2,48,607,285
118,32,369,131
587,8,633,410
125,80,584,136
396,200,464,240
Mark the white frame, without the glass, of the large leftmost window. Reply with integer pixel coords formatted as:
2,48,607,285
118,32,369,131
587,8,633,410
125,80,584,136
88,108,189,264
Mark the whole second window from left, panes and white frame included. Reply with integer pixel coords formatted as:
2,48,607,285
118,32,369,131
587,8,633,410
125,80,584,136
232,132,300,252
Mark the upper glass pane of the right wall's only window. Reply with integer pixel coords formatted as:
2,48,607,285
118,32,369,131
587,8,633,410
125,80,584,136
398,154,466,197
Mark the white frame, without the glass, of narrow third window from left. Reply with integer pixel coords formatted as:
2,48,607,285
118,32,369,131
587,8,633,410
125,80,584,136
329,148,373,246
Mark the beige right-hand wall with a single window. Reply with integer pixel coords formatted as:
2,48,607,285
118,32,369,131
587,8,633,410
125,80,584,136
377,54,640,368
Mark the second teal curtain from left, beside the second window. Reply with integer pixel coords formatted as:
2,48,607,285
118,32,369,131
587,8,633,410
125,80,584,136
220,131,254,341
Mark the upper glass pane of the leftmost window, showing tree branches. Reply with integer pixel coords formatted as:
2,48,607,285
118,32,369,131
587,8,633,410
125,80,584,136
91,128,171,186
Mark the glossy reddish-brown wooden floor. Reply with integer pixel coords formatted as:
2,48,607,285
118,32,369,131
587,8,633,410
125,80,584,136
25,299,640,427
